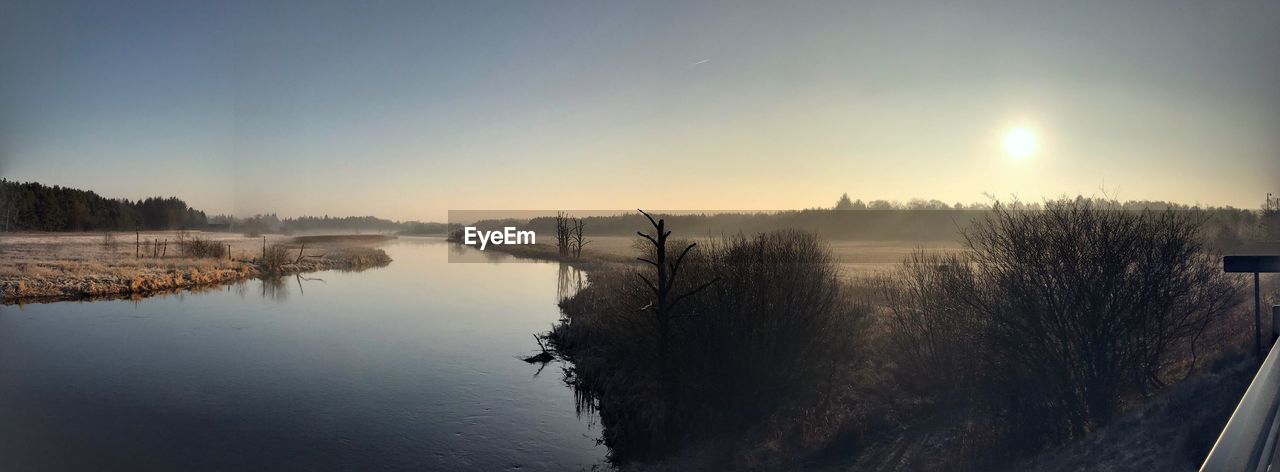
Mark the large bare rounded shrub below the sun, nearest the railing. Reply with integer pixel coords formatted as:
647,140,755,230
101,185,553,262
884,200,1239,450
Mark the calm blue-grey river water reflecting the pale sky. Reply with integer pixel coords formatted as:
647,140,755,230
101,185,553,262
0,238,605,471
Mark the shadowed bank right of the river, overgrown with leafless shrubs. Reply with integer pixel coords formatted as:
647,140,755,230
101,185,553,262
549,202,1280,471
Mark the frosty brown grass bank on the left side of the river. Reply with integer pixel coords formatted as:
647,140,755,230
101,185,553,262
0,232,394,304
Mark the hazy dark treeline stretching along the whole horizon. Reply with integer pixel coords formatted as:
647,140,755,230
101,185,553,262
0,179,1280,248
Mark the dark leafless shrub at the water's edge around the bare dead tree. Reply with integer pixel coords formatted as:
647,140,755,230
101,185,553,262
550,230,865,462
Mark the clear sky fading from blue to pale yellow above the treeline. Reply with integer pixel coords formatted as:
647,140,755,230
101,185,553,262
0,0,1280,220
